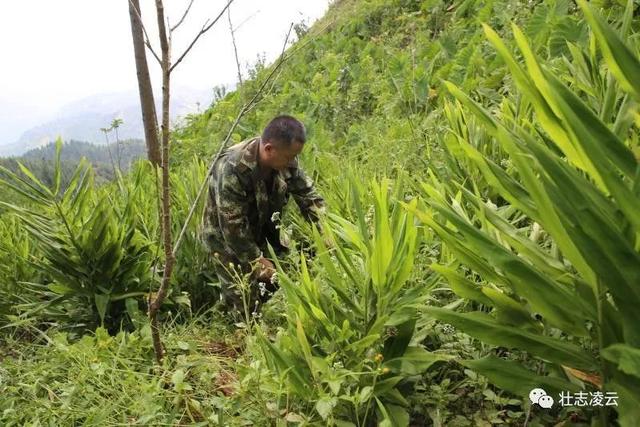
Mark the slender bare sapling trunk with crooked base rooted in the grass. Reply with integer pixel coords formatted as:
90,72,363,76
149,0,175,364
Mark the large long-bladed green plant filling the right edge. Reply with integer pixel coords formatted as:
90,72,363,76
409,1,640,425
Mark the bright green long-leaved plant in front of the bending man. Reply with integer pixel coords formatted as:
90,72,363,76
260,179,446,426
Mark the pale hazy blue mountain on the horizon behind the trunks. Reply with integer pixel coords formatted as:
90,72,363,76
0,87,213,156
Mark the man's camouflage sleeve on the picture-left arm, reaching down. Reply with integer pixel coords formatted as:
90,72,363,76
215,165,262,264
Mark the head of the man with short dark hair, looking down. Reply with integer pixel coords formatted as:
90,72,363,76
260,116,307,170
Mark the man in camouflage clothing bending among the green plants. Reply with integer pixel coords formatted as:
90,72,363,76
204,115,324,312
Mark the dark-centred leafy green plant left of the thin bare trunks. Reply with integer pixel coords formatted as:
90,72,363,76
0,140,151,332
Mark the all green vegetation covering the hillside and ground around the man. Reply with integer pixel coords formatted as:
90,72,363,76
0,0,640,427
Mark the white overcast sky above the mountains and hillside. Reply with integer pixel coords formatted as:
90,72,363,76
0,0,329,142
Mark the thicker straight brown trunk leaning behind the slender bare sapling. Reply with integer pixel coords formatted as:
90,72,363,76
128,0,162,166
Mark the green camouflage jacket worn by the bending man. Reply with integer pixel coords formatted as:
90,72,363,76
203,137,324,265
